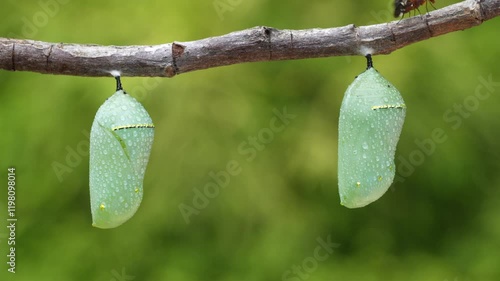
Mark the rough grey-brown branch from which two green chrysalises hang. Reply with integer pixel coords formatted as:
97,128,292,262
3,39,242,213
0,0,500,77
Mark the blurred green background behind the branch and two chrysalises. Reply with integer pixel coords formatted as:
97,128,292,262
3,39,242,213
0,0,500,281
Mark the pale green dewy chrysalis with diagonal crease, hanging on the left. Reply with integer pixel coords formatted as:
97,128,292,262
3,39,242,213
89,75,154,228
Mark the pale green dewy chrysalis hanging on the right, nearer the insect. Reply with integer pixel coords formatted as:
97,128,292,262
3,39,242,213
338,55,406,208
